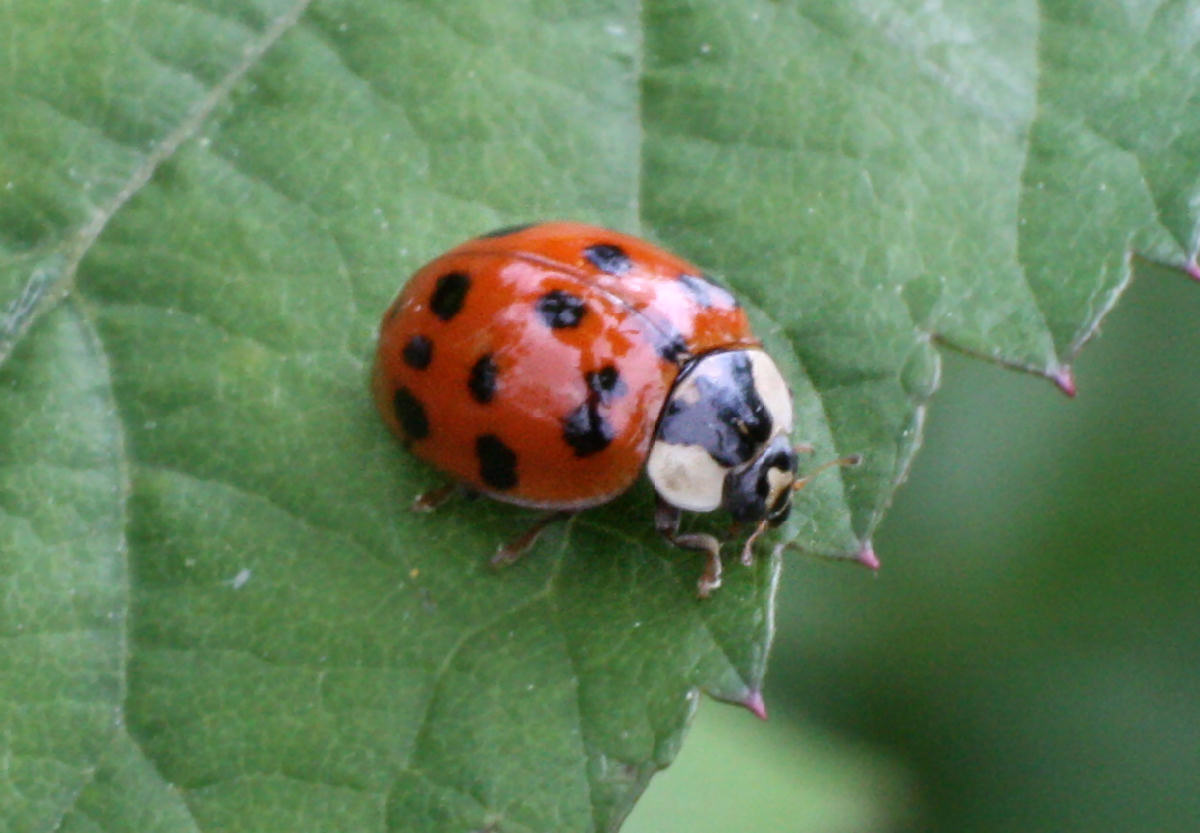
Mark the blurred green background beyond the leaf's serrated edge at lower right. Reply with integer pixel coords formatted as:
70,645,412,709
625,270,1200,833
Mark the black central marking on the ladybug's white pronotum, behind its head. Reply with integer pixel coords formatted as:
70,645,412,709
658,350,772,468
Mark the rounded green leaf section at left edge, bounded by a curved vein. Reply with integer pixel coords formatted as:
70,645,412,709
0,304,128,831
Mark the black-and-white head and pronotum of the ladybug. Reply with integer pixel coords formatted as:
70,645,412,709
646,349,796,526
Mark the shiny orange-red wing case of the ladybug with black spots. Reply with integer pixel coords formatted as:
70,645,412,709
372,222,758,509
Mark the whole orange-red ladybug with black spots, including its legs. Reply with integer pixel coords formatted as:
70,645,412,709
372,222,854,597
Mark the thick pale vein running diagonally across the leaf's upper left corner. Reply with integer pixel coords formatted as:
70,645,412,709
0,0,312,365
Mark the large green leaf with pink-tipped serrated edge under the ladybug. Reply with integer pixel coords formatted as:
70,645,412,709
0,0,1200,831
